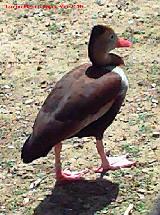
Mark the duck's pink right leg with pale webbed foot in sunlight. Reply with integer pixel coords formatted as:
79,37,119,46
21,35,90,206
95,140,135,173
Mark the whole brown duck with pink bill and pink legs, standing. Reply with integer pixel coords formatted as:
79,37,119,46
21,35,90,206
21,25,135,181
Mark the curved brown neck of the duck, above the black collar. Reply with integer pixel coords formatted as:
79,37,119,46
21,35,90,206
88,41,124,66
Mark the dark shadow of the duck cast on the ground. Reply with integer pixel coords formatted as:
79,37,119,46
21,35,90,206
34,179,119,215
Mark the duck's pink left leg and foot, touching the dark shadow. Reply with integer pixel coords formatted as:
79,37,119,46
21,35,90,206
54,143,87,181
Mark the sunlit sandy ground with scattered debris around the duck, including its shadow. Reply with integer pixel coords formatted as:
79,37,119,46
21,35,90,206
0,0,160,215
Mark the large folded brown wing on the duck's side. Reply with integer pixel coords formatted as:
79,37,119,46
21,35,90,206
34,65,121,142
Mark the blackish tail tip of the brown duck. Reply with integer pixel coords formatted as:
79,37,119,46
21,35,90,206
21,134,52,163
